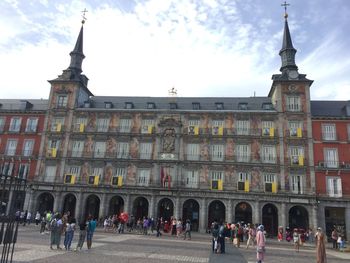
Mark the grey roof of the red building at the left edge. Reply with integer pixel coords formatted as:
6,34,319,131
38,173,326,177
0,99,48,112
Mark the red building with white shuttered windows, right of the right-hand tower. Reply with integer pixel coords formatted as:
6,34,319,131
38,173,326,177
311,101,350,241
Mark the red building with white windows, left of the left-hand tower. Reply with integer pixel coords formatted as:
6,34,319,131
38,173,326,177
0,99,47,212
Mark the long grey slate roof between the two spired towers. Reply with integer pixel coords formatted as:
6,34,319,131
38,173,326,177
85,96,274,111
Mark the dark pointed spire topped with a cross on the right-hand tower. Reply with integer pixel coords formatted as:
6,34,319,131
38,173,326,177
279,1,298,73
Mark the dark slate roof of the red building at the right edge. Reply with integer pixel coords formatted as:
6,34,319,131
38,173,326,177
310,100,350,118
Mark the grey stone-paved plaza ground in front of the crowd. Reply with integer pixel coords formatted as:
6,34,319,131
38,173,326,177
8,225,350,263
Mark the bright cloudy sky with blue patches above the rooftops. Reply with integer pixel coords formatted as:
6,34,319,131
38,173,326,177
0,0,350,100
